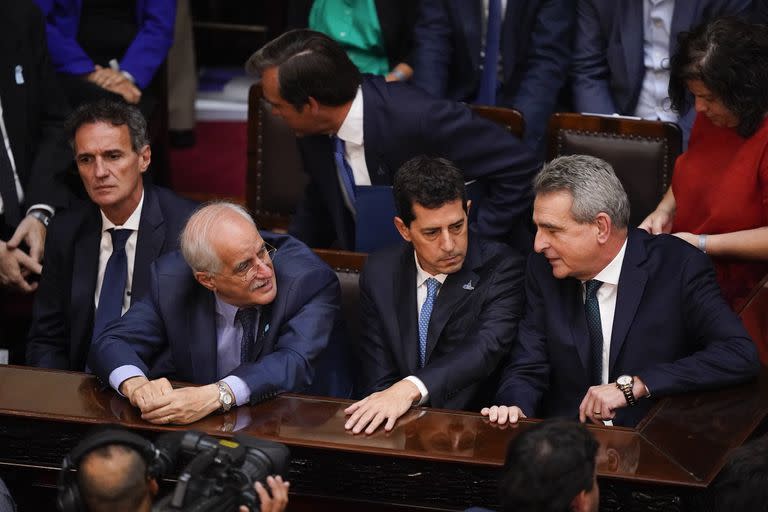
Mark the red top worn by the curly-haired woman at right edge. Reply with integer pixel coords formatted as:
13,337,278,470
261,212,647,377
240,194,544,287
672,115,768,309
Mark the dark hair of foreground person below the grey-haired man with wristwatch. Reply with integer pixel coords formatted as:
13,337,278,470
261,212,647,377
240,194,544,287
499,420,598,512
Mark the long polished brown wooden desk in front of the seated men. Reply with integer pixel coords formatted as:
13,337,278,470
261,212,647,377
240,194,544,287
0,366,768,510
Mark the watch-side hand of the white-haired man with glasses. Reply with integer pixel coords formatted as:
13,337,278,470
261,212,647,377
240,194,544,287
141,384,220,425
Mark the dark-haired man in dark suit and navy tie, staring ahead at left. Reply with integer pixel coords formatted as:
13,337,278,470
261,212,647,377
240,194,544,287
27,101,195,371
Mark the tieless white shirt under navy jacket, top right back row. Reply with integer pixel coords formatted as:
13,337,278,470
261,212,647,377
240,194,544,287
635,0,677,122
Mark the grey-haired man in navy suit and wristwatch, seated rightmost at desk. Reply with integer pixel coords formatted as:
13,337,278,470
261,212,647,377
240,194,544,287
482,155,760,425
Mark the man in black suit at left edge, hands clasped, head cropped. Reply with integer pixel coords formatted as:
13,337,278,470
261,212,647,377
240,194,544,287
0,0,71,293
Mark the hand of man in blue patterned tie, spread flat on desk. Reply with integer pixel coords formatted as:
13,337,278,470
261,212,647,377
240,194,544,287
344,380,421,434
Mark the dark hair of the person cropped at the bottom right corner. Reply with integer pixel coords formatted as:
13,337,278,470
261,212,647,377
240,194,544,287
712,436,768,512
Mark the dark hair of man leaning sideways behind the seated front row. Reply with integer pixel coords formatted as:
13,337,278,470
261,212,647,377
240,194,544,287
245,29,362,110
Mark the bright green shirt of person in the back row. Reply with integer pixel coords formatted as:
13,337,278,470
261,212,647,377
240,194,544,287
309,0,389,75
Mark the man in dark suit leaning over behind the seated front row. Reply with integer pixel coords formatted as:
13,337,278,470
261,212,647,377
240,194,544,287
247,30,538,249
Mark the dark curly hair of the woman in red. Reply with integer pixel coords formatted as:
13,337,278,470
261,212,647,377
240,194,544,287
669,17,768,137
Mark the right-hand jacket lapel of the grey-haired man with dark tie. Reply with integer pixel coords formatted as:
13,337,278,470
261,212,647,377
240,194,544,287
609,231,648,379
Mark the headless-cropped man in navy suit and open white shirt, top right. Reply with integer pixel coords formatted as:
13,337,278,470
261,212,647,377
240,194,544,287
571,0,753,145
